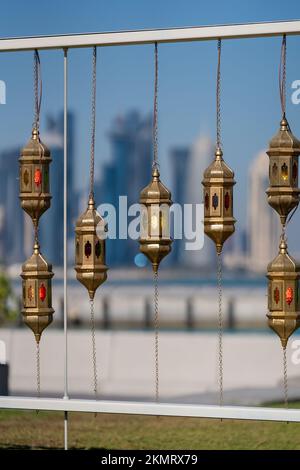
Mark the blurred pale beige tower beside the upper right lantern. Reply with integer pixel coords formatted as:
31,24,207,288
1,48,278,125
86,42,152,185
247,151,280,273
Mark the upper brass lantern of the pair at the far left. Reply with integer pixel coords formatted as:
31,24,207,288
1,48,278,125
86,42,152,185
19,128,52,227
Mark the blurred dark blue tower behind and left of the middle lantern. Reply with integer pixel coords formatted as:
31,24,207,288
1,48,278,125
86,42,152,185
96,111,152,266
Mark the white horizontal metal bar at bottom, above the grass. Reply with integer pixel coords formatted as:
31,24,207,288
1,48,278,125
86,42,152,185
0,397,300,422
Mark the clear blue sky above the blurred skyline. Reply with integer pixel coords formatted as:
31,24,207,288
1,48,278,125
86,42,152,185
0,0,300,248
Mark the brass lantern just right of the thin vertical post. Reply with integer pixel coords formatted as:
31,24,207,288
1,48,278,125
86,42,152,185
75,197,107,300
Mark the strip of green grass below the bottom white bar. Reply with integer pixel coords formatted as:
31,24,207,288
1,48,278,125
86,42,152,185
0,402,300,450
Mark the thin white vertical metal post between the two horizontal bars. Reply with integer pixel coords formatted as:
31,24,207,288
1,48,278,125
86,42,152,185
64,49,69,450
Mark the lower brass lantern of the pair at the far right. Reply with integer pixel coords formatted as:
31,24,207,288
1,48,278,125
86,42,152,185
267,237,300,348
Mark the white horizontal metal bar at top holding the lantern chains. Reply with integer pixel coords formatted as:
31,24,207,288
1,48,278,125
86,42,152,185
0,20,300,52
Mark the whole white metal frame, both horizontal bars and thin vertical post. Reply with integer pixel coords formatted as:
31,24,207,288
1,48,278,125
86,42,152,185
0,20,300,449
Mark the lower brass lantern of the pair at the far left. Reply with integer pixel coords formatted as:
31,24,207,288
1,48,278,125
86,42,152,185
21,242,54,343
